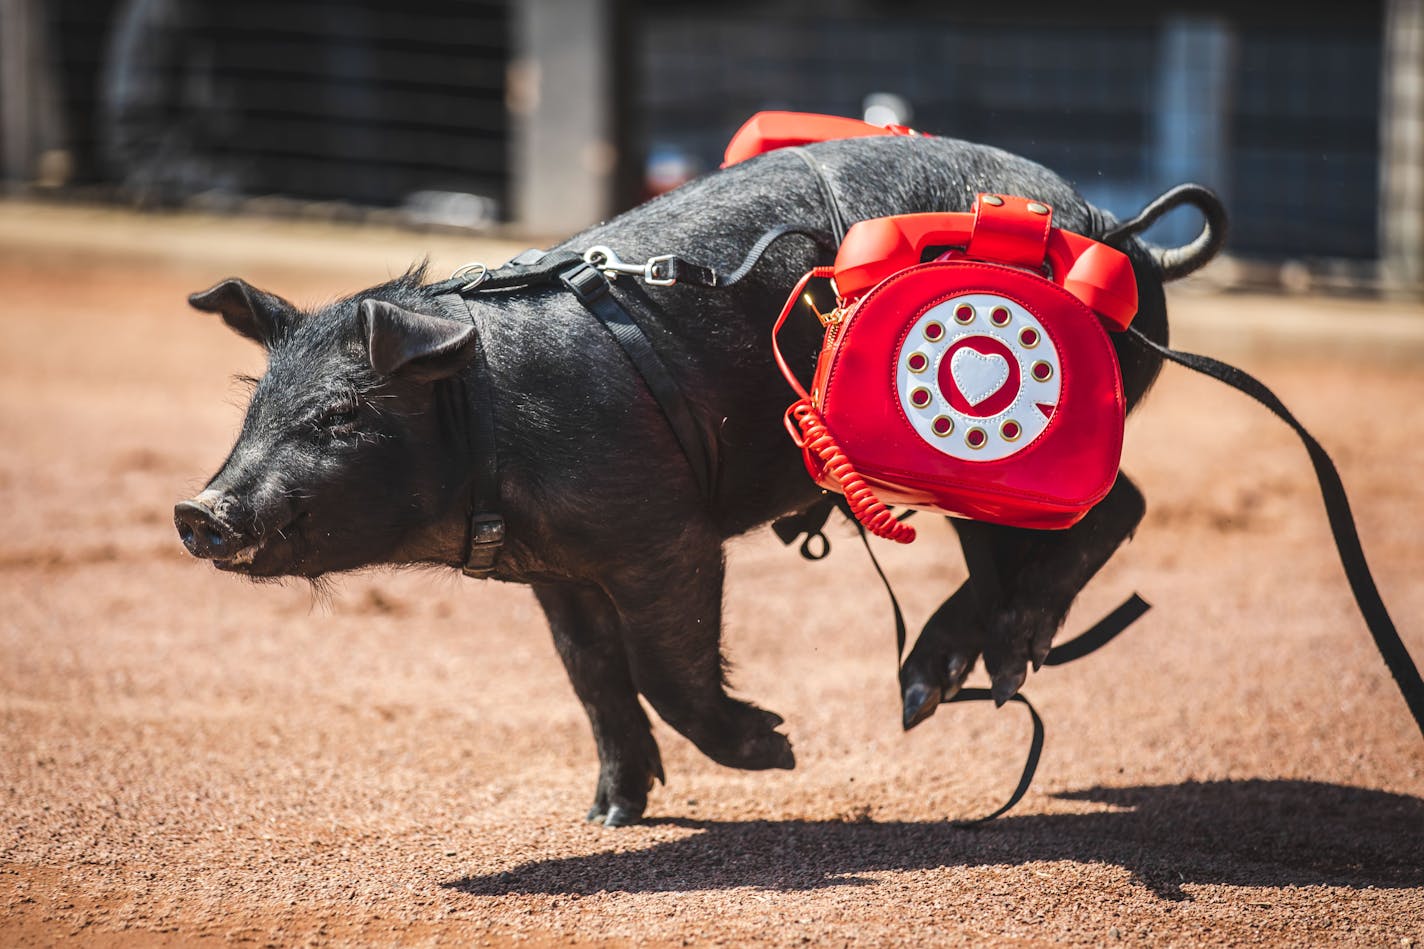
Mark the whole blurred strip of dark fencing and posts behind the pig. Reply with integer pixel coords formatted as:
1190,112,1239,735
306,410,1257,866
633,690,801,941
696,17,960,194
0,0,1424,296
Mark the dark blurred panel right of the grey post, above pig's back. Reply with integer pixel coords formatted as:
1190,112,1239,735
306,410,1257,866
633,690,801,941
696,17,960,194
637,0,1383,262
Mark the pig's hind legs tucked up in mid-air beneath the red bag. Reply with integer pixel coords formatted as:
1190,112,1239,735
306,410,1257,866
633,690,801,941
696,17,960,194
900,472,1146,728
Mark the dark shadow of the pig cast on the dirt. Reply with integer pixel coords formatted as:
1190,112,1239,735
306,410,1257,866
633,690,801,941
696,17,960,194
446,781,1424,899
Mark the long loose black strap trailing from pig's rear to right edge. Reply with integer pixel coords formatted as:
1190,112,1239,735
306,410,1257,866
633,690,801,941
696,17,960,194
1128,326,1424,734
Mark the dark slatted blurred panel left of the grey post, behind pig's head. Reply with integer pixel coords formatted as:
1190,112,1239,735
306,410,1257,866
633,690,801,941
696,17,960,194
0,0,510,218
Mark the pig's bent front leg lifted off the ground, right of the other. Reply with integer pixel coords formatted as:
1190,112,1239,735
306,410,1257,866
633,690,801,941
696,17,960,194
607,524,796,771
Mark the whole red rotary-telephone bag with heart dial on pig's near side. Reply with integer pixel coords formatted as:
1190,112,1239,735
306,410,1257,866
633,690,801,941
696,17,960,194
776,194,1136,541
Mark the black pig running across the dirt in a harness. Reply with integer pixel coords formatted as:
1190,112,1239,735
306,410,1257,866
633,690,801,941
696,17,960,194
175,137,1215,826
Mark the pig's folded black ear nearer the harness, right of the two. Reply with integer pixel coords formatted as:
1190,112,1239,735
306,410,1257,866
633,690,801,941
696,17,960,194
359,299,478,382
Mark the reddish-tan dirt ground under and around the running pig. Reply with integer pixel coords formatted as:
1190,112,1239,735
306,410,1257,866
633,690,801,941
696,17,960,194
0,199,1424,948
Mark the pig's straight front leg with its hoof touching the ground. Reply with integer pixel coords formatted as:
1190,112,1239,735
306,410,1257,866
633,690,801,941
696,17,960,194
534,583,665,826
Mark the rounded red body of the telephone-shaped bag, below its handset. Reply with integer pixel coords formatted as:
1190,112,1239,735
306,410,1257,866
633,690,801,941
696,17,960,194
805,261,1124,529
